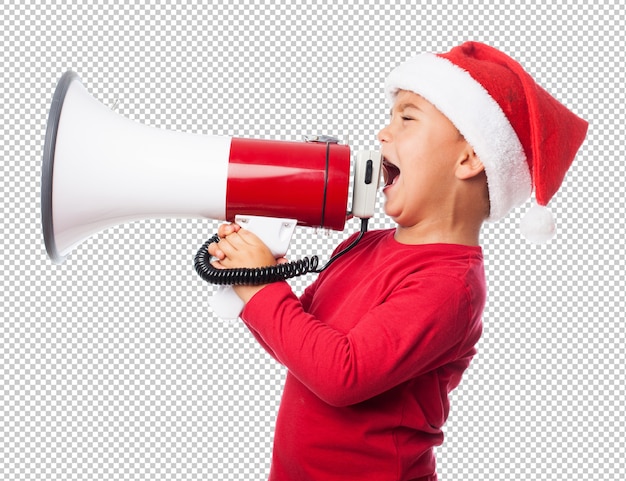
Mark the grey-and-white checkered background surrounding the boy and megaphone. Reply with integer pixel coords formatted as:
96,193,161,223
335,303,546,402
0,0,626,481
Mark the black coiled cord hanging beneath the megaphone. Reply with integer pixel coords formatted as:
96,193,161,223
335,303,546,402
193,219,368,286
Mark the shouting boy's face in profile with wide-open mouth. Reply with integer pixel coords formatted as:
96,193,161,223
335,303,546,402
378,90,471,227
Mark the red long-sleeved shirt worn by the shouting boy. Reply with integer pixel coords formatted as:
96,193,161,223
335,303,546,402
242,230,486,481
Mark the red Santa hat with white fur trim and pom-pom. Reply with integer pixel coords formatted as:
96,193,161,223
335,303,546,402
385,42,588,242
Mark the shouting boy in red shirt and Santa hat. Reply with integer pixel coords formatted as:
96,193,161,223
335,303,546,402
210,42,587,481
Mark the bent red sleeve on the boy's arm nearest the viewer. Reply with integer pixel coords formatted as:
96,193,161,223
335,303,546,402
242,275,480,406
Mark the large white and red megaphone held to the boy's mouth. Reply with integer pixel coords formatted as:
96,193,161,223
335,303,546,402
41,72,380,316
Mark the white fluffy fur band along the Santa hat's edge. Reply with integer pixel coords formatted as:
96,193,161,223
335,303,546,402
385,53,532,221
